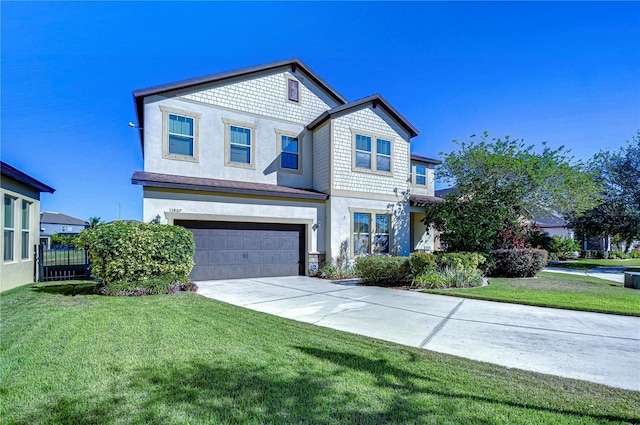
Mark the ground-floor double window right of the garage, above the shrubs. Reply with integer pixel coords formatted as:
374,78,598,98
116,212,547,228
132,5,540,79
351,211,391,256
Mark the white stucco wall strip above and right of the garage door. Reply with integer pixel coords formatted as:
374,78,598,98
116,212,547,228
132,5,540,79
143,188,326,254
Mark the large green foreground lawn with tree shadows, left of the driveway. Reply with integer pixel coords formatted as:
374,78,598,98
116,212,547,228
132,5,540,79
0,282,640,424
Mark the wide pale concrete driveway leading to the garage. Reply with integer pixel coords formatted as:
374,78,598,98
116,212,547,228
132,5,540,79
198,276,640,391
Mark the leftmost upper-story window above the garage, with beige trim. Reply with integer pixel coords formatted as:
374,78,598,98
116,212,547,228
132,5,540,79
160,106,202,162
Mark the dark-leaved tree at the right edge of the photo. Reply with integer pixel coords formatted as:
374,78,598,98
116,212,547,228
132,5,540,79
567,130,640,247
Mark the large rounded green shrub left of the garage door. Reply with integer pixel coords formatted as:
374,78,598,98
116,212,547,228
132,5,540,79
77,221,195,285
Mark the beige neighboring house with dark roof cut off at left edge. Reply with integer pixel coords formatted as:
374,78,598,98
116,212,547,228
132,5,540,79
0,161,55,291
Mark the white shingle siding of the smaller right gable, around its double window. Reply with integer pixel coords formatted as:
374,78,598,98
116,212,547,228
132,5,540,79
333,107,409,195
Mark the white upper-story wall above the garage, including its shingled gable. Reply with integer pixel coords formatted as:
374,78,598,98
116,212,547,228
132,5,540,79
143,71,337,188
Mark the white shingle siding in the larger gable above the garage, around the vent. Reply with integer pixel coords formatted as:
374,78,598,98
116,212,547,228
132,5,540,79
182,71,338,124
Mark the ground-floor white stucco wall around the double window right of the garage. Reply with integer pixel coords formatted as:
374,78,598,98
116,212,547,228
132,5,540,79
325,196,410,259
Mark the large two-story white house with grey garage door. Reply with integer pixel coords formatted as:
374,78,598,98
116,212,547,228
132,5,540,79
132,59,438,280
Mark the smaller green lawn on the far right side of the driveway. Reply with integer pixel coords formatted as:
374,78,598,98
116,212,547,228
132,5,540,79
424,272,640,316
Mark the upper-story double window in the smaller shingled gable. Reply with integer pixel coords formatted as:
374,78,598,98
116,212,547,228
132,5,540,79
352,131,393,175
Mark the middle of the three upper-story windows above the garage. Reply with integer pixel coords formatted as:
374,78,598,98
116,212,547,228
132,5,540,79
223,119,256,169
